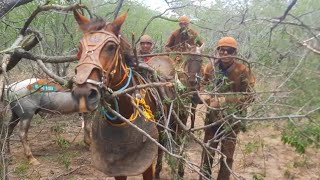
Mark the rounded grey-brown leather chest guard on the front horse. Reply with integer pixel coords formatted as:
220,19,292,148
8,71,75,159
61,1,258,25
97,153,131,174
91,114,158,176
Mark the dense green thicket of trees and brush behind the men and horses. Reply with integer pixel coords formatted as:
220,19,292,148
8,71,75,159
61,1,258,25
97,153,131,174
0,0,320,177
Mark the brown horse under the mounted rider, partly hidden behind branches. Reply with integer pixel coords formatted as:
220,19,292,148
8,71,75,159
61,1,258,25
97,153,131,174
147,47,202,179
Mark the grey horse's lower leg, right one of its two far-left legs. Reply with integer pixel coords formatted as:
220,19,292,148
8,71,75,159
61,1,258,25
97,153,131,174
19,118,40,165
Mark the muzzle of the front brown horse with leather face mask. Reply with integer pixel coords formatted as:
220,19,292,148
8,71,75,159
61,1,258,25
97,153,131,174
72,84,101,112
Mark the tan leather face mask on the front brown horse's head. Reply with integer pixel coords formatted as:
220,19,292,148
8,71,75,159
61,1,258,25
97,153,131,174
75,23,126,87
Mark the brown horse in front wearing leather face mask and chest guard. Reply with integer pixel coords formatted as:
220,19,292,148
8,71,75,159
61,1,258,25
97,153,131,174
73,11,158,180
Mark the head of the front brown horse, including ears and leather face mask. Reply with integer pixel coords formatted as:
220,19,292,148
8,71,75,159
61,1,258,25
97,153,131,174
72,11,127,112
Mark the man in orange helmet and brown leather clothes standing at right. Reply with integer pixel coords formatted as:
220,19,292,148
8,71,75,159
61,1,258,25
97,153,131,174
200,37,255,180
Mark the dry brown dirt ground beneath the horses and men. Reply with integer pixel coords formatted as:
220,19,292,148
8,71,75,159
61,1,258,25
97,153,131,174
5,105,320,180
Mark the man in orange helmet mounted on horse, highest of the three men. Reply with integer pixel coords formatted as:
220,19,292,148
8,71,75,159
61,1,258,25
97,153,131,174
165,16,203,52
